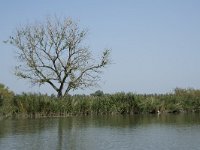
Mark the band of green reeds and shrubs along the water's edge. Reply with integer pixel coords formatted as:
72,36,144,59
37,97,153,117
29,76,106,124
0,85,200,118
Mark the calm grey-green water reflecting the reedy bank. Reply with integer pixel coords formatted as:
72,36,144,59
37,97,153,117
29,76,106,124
0,114,200,150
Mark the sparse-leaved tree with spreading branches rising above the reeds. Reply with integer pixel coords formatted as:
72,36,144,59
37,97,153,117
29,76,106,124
7,18,110,97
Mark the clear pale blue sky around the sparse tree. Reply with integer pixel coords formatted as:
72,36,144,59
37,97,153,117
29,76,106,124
0,0,200,94
